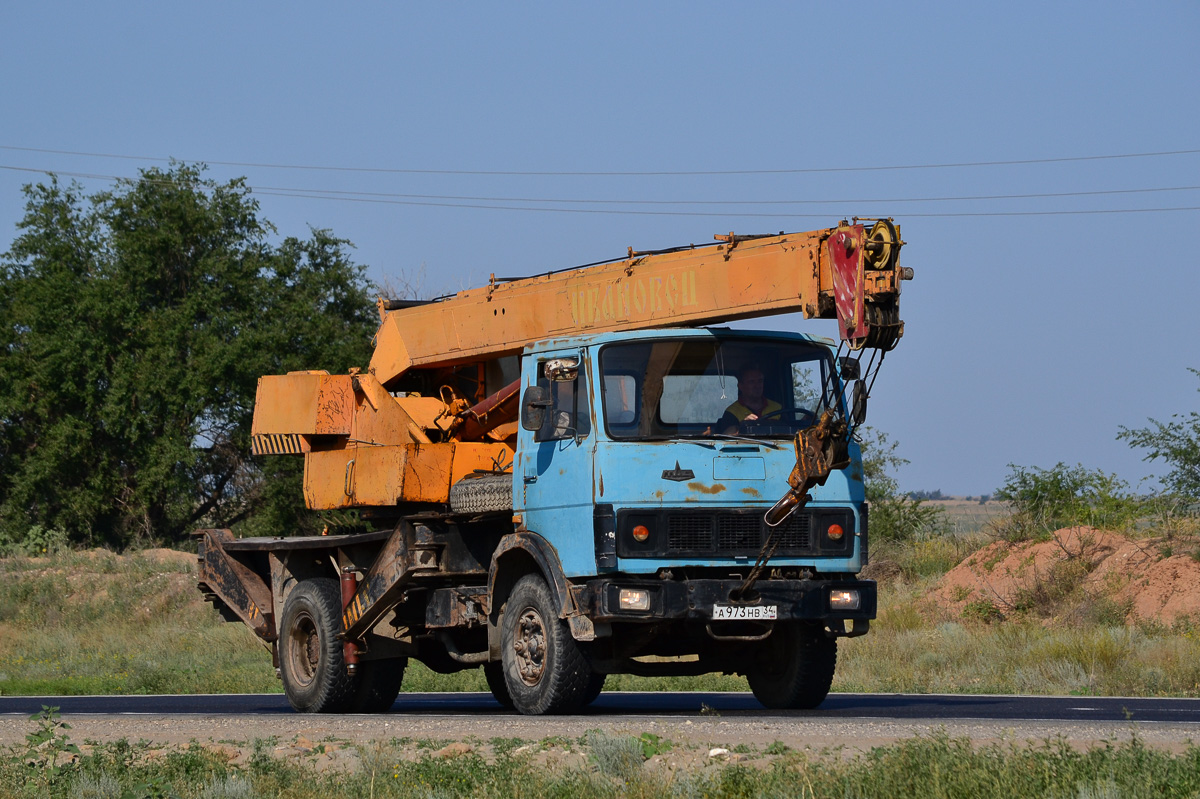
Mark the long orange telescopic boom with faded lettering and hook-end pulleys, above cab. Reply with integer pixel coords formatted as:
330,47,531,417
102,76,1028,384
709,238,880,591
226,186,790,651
368,221,911,385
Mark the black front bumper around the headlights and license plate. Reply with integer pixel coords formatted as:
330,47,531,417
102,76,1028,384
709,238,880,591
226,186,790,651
571,577,877,635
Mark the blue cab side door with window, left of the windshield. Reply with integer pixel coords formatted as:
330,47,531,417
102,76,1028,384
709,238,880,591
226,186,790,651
514,349,596,577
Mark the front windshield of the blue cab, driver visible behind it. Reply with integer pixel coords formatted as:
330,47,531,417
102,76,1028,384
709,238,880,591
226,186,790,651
600,338,840,439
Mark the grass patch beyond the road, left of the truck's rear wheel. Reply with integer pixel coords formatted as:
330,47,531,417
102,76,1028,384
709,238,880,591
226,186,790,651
0,552,280,695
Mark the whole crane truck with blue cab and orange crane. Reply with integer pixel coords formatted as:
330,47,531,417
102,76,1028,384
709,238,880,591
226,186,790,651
196,220,912,715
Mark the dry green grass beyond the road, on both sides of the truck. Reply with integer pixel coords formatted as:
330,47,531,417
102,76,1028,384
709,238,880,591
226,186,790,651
7,527,1200,696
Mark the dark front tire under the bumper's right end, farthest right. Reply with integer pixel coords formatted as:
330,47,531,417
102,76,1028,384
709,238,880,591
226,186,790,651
746,624,838,710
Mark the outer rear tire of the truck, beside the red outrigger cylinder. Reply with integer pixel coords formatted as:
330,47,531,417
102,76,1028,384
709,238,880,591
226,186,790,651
280,577,356,713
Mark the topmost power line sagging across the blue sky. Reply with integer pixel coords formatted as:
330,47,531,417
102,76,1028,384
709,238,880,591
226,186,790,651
0,144,1200,178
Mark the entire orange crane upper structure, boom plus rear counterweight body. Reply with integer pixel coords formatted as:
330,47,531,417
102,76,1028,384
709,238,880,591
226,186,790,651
251,221,911,509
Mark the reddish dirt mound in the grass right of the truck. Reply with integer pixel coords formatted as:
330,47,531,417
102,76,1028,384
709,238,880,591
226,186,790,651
935,527,1200,624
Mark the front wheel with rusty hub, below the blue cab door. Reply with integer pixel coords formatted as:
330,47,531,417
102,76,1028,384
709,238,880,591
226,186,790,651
500,575,592,716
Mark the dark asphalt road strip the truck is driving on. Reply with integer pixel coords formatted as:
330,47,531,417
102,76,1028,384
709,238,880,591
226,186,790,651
0,692,1200,725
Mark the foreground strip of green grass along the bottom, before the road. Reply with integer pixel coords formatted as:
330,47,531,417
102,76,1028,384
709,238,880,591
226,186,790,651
0,716,1200,799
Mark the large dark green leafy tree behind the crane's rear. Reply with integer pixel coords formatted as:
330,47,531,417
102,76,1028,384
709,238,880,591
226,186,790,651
0,164,374,546
